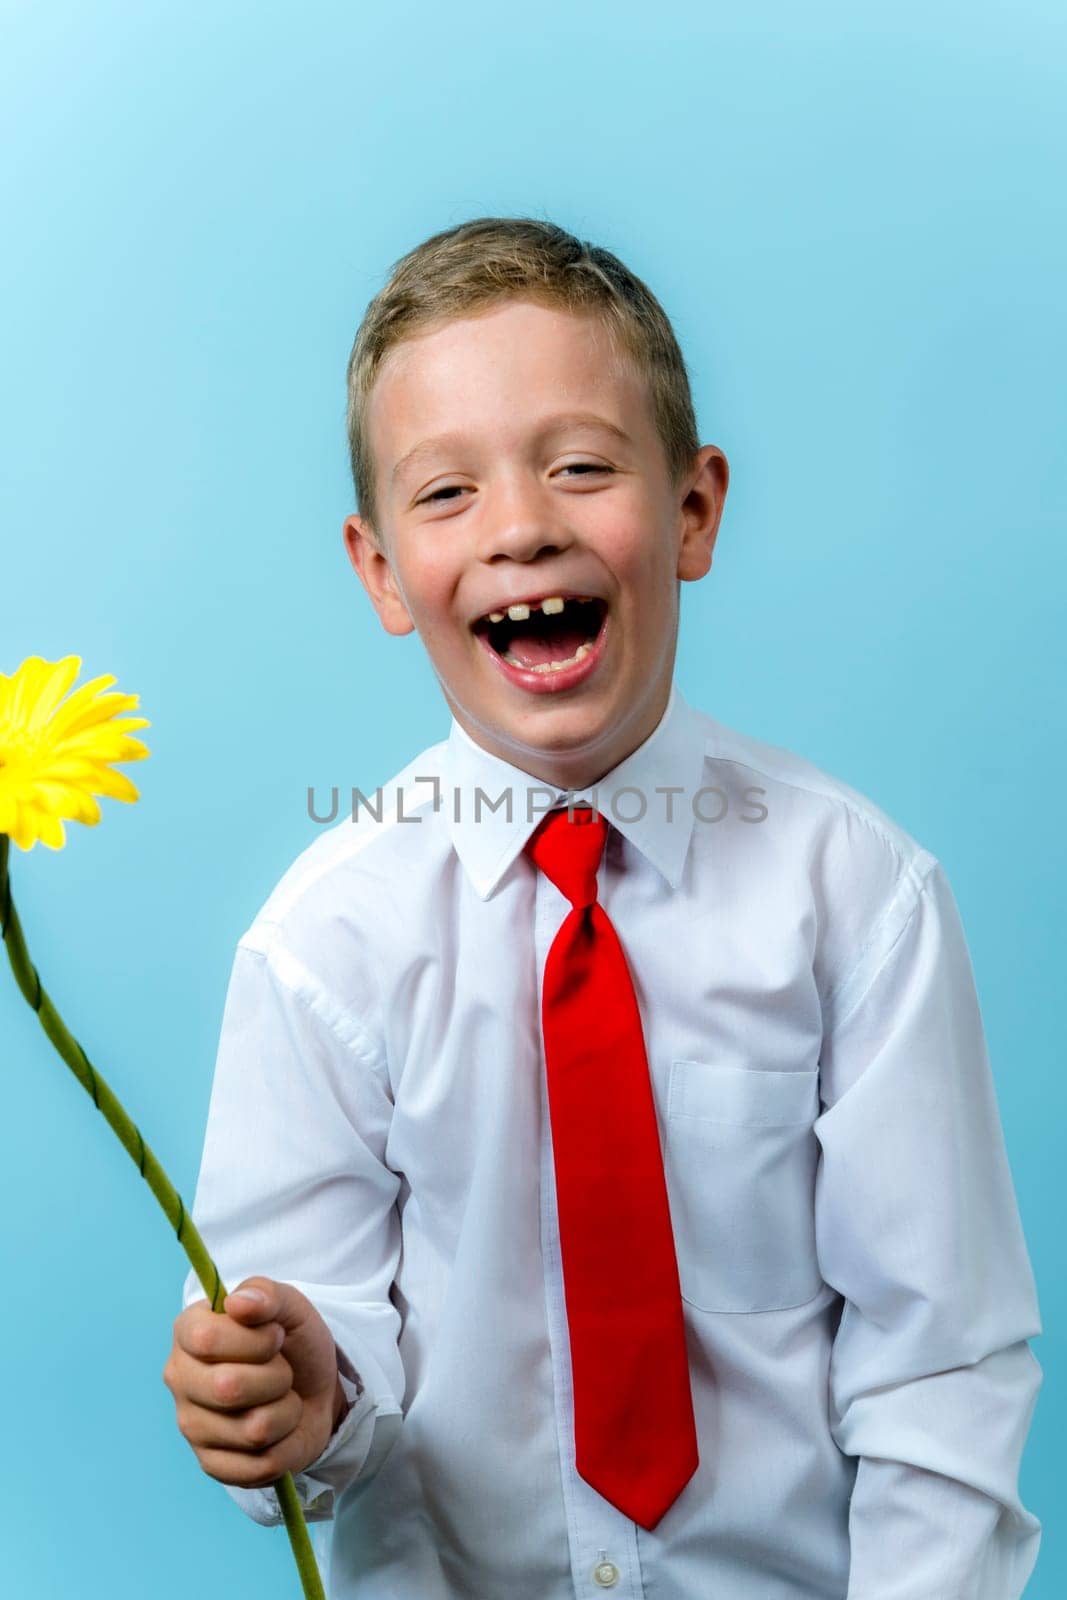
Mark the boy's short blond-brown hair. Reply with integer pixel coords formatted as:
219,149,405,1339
347,216,699,530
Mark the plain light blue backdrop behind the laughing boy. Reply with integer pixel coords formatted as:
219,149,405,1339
0,0,1067,1600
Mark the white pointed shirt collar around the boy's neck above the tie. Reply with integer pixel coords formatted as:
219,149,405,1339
440,680,705,899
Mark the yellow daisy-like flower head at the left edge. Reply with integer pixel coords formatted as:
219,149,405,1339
0,656,150,850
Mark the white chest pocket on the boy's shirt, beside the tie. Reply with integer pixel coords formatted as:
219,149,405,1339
664,1061,822,1312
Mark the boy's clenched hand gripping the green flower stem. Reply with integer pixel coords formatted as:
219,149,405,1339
163,1277,346,1490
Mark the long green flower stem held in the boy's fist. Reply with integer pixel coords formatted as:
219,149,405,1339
0,834,325,1600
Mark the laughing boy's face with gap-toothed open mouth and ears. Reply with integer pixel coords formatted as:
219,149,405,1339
344,301,728,789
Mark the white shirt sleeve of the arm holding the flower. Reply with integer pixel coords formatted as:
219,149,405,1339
182,928,405,1526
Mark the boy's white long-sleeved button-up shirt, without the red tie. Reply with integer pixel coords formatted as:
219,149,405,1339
182,685,1043,1600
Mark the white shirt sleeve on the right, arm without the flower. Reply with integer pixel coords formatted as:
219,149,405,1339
814,853,1043,1600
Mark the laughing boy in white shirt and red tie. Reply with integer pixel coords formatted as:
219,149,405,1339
163,218,1041,1600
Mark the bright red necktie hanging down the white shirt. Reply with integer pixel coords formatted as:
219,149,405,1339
526,806,699,1528
